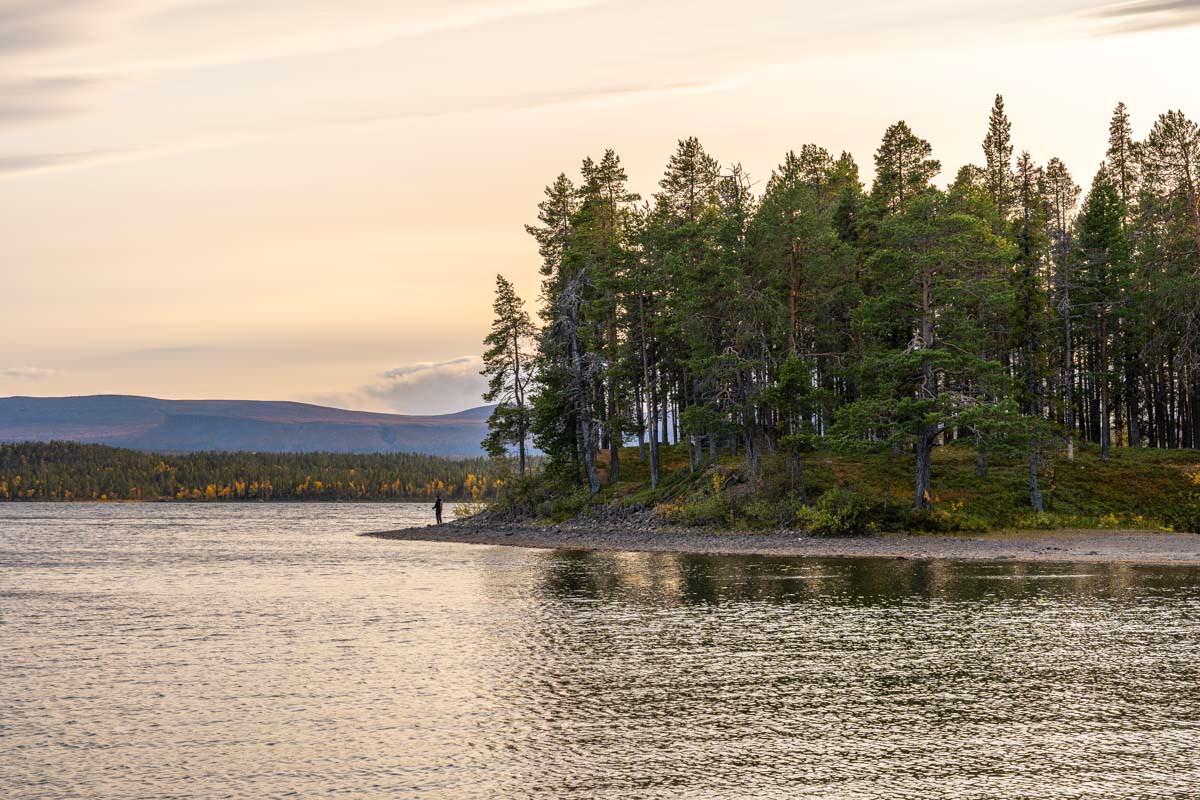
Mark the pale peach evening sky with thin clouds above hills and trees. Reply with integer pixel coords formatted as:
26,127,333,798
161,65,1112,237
0,0,1200,414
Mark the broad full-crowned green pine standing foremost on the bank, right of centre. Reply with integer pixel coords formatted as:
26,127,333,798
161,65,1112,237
839,190,1012,510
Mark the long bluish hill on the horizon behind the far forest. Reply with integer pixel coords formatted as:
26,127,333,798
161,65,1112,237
0,395,491,456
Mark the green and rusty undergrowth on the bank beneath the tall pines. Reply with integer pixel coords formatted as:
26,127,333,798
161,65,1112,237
490,445,1200,536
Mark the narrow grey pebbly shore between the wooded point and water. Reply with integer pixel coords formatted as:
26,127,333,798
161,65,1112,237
364,521,1200,566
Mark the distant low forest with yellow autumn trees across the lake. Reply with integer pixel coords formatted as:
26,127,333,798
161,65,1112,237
0,441,503,501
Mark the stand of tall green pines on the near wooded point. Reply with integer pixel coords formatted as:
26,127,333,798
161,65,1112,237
485,96,1200,510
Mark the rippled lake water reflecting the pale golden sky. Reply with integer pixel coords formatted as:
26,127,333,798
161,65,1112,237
0,504,1200,800
